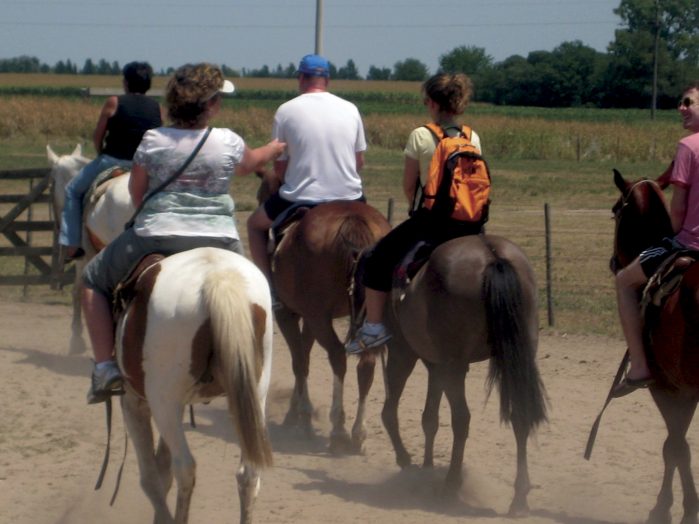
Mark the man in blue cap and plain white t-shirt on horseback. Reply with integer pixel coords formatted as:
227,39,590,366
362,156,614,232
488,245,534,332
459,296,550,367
248,55,366,294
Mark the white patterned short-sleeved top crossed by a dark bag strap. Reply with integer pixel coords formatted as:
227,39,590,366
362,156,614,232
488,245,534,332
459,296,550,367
134,127,245,239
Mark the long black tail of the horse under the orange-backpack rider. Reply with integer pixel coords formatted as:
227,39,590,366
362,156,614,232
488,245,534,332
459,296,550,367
482,251,547,429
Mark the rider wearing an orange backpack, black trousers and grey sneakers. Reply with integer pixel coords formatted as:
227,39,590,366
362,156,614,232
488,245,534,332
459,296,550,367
345,73,490,354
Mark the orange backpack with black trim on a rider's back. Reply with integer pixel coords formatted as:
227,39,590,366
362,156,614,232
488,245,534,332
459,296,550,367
422,123,490,223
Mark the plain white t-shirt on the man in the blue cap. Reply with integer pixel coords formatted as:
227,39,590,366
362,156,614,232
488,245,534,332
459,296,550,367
272,92,366,202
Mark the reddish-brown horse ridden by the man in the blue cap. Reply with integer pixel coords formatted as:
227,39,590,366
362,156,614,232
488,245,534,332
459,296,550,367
272,202,390,452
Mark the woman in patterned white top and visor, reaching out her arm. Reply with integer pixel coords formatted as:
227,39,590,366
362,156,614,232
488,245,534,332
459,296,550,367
82,64,285,403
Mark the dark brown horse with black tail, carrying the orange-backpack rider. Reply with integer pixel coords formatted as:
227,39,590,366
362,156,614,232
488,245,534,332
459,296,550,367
382,235,546,515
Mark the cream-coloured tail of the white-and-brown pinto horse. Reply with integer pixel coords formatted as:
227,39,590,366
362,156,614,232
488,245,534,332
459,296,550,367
204,271,272,467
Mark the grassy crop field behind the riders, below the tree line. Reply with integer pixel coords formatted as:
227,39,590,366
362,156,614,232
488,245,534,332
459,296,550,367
0,74,683,336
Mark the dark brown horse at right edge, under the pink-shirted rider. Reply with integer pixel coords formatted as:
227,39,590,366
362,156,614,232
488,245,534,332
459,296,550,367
611,170,699,524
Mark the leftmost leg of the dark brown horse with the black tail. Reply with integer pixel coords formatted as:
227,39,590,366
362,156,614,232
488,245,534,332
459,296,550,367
381,340,417,469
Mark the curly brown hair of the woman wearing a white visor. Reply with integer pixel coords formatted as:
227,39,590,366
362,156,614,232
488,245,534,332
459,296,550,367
165,63,223,127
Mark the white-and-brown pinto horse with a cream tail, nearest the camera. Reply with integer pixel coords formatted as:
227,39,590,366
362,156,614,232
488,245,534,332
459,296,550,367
116,248,273,524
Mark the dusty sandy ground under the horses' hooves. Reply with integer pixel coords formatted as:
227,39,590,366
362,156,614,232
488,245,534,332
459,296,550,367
0,301,696,524
